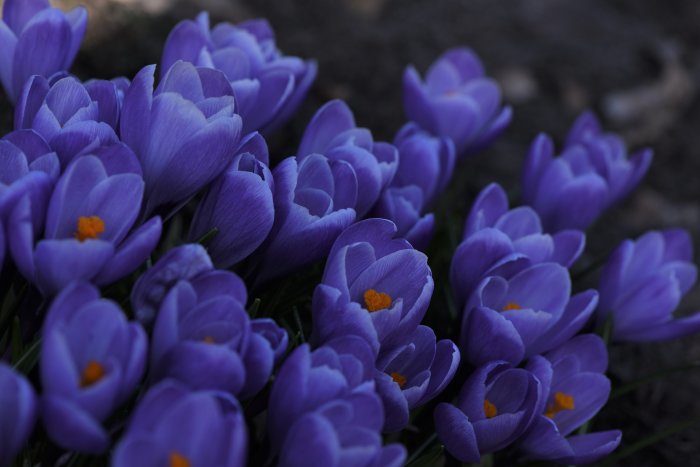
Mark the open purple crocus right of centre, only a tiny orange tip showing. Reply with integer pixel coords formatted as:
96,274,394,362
460,263,598,365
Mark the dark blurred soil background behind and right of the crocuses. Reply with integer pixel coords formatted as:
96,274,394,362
5,0,700,466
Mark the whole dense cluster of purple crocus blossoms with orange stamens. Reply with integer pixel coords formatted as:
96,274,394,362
0,0,700,467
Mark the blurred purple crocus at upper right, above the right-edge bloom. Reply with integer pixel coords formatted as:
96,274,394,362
523,112,652,232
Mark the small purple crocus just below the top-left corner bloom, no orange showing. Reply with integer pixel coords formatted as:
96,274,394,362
15,76,120,169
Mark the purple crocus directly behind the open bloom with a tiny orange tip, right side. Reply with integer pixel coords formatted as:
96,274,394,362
450,183,585,307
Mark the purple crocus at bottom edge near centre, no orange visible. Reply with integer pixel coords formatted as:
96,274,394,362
268,336,406,467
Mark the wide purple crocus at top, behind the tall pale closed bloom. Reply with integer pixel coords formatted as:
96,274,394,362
161,12,316,134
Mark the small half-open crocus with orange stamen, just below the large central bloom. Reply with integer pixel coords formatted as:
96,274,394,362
374,326,459,432
